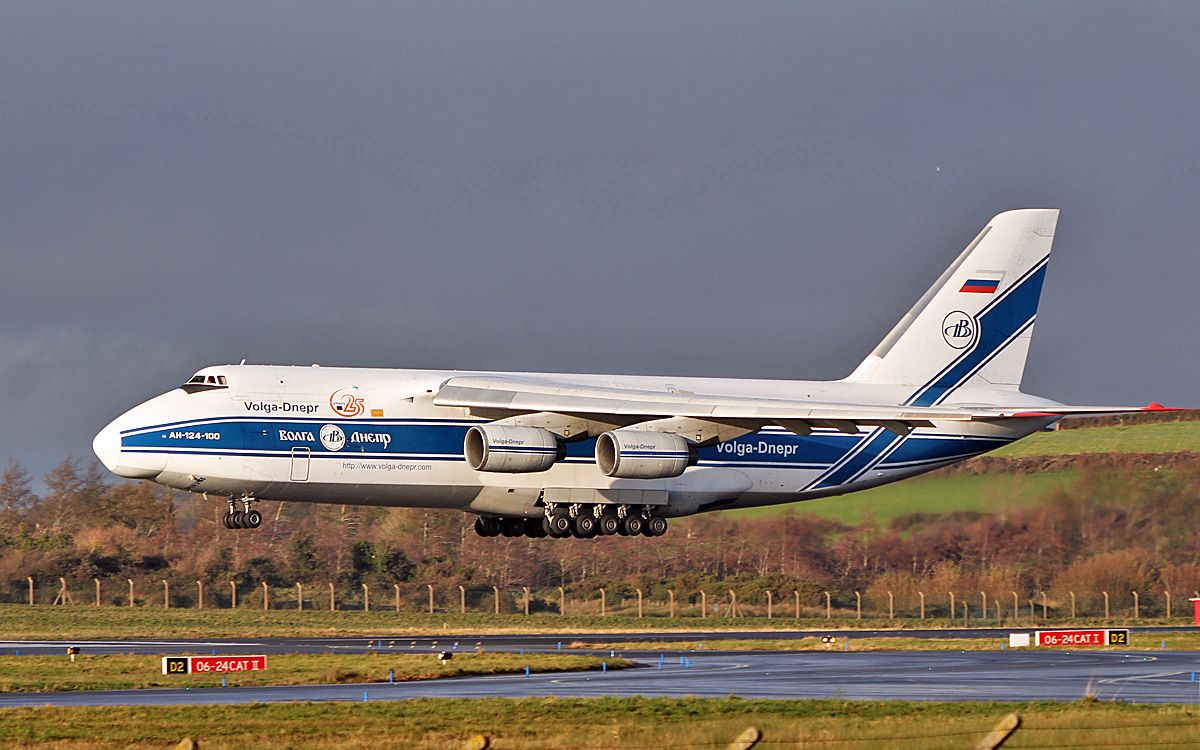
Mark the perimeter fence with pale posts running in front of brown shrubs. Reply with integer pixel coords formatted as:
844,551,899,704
0,576,1200,625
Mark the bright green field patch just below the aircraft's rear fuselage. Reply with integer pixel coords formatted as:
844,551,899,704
722,470,1081,526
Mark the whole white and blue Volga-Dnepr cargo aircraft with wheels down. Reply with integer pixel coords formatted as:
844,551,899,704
94,209,1163,539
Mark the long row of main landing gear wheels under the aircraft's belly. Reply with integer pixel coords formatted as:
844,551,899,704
475,504,667,539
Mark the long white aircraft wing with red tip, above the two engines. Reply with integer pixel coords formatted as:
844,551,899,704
433,376,1165,439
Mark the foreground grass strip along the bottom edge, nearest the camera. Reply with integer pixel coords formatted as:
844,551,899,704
0,698,1200,750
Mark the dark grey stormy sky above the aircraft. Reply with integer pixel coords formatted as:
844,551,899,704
0,0,1200,473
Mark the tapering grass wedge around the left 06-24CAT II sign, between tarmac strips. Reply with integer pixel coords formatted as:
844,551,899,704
0,649,630,692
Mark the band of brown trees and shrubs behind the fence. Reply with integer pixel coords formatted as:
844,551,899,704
0,455,1200,616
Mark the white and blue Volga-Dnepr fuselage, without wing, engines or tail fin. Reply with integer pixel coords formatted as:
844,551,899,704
95,365,1054,516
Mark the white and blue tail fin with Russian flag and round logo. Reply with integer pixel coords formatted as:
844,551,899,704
847,209,1058,406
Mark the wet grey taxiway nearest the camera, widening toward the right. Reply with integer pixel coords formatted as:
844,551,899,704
0,650,1200,708
